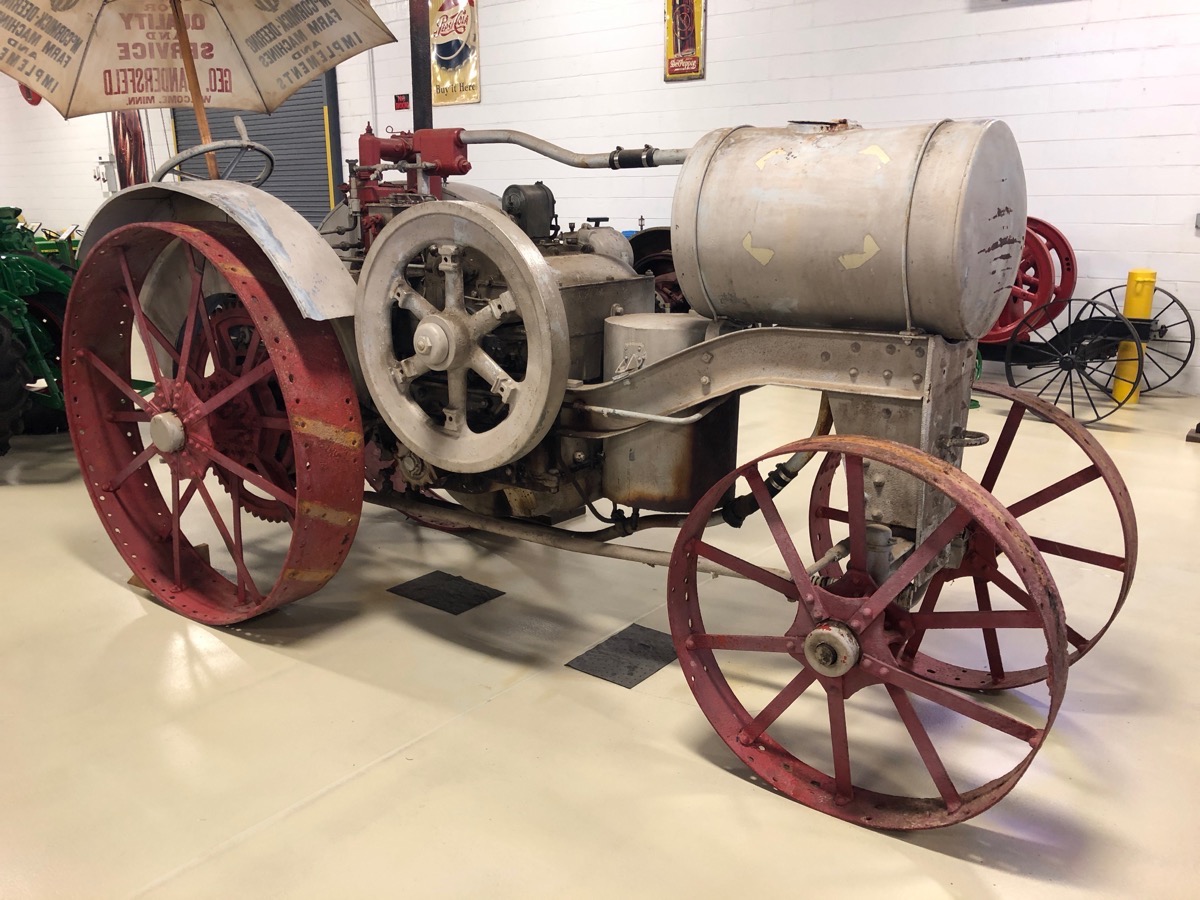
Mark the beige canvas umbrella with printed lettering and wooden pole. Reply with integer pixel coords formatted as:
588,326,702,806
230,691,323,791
0,0,396,178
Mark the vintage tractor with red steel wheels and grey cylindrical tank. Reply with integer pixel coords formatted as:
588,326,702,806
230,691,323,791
64,121,1136,829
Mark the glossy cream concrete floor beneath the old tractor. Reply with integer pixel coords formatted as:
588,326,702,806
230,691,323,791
0,391,1200,900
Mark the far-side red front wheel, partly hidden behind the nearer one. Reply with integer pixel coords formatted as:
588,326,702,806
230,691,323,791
809,384,1138,690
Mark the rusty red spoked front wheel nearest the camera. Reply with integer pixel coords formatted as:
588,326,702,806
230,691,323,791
667,437,1066,830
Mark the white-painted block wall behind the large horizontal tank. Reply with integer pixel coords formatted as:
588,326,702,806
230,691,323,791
338,0,1200,394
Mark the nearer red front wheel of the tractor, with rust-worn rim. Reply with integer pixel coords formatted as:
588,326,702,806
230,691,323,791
667,437,1067,829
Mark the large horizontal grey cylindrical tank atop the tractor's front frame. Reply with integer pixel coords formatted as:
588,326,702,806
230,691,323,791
671,120,1026,340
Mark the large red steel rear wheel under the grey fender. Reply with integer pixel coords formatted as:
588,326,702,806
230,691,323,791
64,222,364,624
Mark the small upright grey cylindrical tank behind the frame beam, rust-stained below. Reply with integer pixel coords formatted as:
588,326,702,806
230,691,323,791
604,313,738,512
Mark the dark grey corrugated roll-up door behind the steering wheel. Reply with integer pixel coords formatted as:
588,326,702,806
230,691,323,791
174,78,330,226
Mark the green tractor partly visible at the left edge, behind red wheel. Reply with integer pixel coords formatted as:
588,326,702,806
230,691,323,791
0,206,78,455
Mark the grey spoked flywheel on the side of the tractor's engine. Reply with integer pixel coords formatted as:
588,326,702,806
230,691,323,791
354,200,570,473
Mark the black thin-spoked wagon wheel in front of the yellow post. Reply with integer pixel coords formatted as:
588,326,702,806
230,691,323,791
1004,299,1144,424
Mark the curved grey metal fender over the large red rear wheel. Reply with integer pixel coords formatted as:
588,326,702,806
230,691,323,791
79,181,355,322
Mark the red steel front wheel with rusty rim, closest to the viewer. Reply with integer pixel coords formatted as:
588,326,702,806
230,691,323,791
667,437,1067,830
